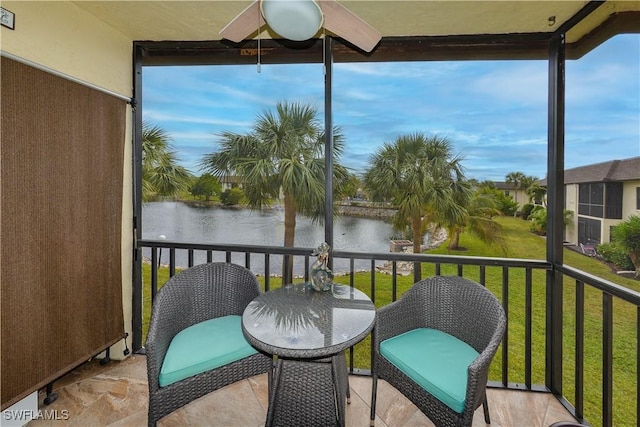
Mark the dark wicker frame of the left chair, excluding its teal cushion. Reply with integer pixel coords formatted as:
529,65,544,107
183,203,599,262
145,262,273,426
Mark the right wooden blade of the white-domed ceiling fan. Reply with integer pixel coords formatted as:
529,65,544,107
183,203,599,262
318,0,382,52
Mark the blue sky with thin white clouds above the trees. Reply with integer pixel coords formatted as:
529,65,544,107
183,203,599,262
142,34,640,181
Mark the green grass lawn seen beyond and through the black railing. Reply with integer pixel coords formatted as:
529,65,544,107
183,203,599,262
143,217,640,425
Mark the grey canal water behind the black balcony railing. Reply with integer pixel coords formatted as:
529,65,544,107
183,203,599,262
142,202,394,275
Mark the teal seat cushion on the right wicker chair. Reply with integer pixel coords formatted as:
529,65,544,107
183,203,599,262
380,328,479,413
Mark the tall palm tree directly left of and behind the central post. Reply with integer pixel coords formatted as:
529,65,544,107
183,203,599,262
201,102,349,283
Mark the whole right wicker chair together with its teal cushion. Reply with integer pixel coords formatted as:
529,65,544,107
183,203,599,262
371,276,506,426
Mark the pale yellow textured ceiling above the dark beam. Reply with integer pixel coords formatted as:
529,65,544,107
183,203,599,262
73,0,640,51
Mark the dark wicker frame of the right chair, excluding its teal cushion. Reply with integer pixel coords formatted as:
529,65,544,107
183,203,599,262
371,276,506,426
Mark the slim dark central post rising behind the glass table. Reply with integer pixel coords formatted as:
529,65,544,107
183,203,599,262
323,35,333,268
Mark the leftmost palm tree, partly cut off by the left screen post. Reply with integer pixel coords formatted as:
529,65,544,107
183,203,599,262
142,122,192,201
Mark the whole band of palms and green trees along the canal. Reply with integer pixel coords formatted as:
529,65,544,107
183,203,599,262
142,102,640,277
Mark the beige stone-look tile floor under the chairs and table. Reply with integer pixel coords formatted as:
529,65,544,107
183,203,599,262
28,355,572,427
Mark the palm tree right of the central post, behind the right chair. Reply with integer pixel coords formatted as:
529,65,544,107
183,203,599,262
364,133,464,280
